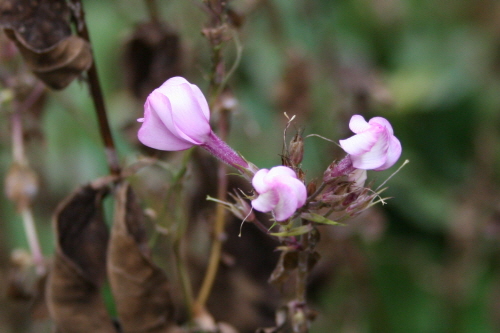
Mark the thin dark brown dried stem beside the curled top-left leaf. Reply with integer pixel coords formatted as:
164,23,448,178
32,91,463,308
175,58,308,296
74,0,121,176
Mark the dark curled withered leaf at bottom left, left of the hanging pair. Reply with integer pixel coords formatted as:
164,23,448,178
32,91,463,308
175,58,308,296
47,185,116,333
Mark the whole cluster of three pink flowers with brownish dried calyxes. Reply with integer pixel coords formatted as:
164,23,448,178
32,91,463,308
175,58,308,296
138,77,401,222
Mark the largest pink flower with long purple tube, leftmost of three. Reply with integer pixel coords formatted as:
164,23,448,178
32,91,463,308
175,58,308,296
137,76,250,174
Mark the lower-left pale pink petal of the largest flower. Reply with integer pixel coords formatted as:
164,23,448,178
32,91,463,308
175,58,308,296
137,101,193,151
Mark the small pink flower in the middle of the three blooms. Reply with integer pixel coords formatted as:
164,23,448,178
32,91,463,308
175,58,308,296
252,166,307,221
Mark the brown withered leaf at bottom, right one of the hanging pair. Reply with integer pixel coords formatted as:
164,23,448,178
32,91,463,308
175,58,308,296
107,183,173,333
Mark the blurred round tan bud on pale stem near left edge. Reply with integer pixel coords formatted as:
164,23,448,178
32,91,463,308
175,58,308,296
5,163,38,209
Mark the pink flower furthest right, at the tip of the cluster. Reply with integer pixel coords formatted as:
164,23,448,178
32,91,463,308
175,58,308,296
340,115,401,171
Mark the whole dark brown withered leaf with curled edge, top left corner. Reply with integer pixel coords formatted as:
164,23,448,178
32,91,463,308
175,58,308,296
0,0,92,89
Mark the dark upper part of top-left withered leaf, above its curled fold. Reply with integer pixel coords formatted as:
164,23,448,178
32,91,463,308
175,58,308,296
0,0,71,52
